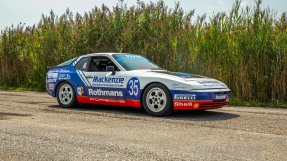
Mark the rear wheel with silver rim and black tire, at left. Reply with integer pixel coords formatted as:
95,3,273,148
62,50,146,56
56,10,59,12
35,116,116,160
57,82,79,108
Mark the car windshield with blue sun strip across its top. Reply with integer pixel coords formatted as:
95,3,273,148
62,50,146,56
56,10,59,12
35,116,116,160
113,54,161,71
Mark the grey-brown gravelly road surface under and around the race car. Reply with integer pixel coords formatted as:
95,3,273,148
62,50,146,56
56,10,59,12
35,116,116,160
0,91,287,161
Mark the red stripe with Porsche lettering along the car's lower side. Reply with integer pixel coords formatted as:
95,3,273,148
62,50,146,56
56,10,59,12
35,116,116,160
77,96,140,108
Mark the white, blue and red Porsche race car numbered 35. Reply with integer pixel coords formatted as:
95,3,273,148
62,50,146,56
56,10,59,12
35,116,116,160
46,53,230,116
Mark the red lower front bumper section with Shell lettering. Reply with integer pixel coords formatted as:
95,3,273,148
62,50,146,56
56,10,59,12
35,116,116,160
173,99,228,110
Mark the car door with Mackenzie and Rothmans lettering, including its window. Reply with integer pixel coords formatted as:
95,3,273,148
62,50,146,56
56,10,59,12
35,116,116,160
85,56,127,105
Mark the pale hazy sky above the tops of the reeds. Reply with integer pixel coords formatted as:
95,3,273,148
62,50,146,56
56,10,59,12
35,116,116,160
0,0,287,30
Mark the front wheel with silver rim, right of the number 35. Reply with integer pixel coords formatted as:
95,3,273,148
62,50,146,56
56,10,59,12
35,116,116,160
141,83,173,116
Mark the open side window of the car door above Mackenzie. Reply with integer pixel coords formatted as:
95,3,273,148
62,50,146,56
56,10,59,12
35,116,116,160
89,56,120,72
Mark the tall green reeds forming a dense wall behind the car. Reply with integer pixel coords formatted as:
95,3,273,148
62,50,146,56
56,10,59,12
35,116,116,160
0,0,287,106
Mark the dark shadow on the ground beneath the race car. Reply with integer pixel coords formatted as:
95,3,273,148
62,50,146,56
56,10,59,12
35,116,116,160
48,105,240,121
